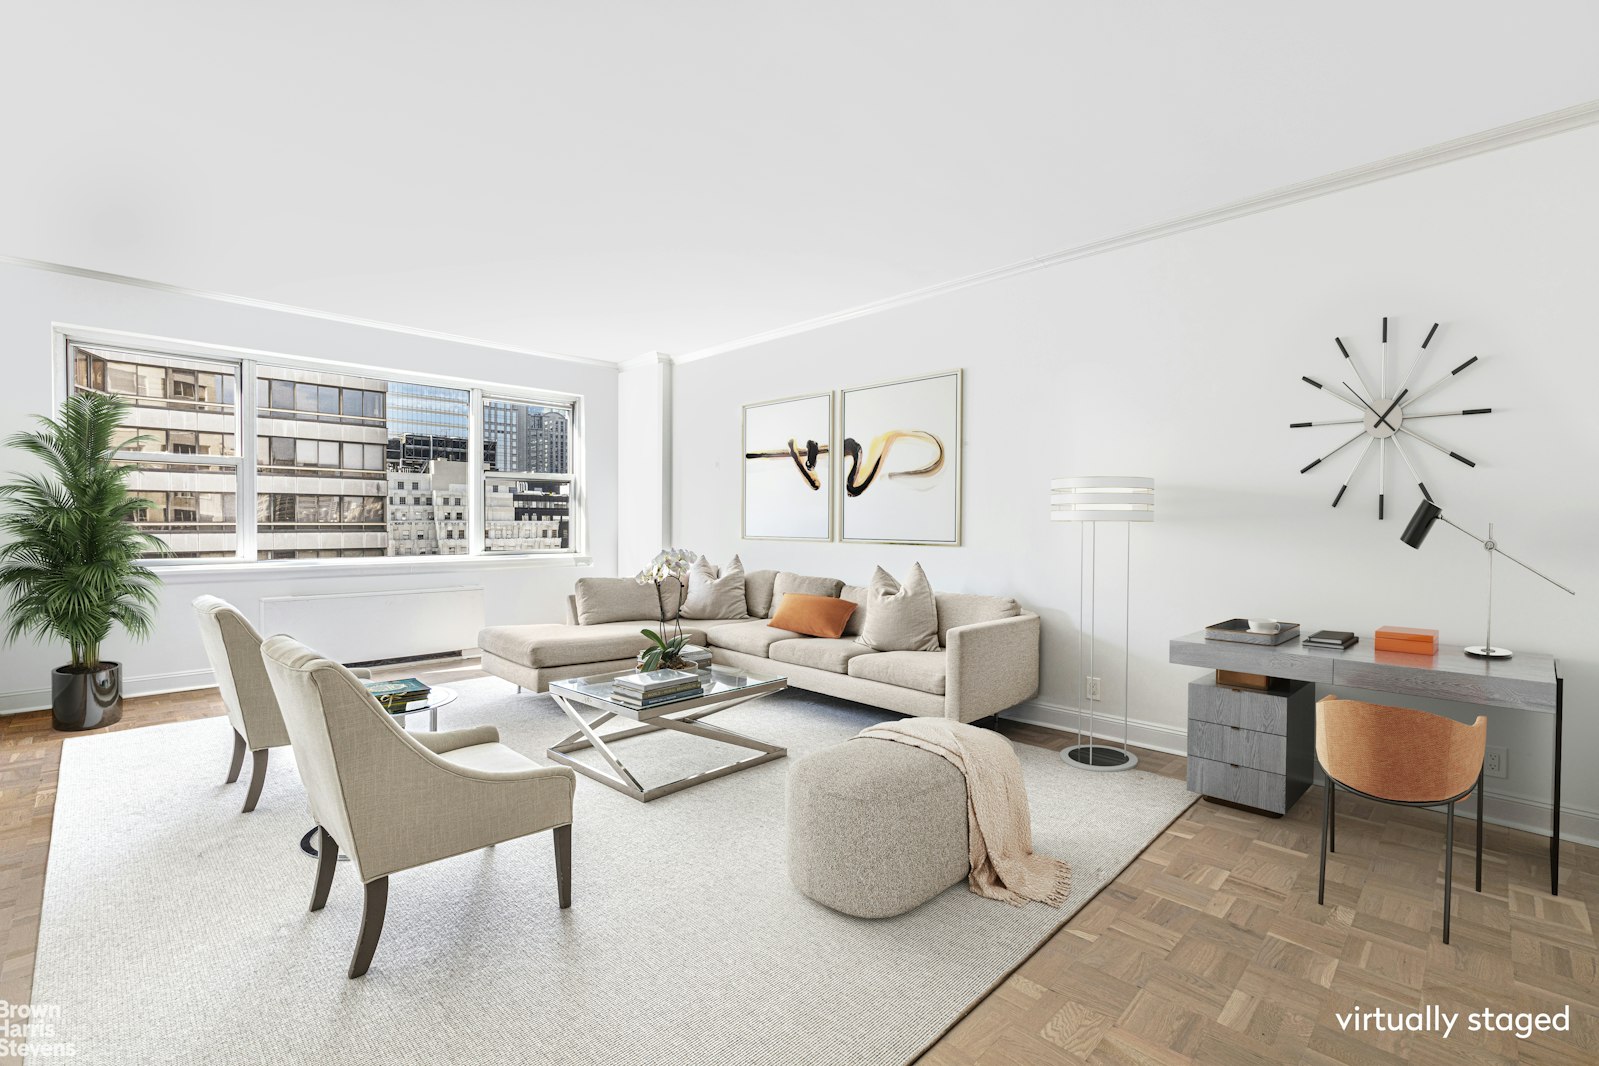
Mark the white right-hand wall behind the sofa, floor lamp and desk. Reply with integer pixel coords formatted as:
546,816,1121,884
673,128,1599,837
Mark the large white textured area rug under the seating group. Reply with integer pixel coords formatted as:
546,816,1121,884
34,679,1193,1066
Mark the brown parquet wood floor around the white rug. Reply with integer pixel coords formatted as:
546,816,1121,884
0,662,1599,1066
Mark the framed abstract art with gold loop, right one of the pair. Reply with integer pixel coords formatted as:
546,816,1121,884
838,371,963,545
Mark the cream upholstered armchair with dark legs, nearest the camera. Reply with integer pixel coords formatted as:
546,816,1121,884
261,636,577,977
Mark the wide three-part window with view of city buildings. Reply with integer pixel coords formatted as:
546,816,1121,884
67,344,579,561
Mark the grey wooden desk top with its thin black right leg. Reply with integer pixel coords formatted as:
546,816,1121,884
1170,631,1565,895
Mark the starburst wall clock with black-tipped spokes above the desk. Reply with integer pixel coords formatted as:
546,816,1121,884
1289,318,1493,519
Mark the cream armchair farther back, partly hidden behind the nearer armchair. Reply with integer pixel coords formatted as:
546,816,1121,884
193,596,371,813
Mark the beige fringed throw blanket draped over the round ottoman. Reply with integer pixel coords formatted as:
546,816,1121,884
859,718,1071,906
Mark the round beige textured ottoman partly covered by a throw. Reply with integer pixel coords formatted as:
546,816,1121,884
788,738,971,917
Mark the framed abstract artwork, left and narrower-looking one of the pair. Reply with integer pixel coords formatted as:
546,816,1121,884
742,392,833,540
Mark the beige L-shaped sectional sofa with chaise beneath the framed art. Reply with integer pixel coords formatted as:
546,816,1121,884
478,571,1039,722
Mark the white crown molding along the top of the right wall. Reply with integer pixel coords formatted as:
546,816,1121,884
673,101,1599,363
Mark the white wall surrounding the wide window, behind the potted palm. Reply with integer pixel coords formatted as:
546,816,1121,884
0,264,617,713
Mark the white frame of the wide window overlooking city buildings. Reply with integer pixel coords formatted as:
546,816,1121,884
51,323,592,577
